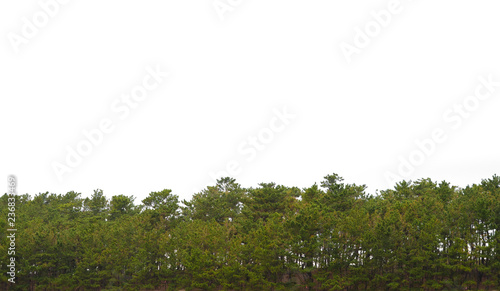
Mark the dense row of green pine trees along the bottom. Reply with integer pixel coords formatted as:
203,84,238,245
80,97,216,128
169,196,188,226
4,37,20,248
0,174,500,290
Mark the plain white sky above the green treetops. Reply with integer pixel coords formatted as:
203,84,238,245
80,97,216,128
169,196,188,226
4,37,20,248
0,0,500,202
